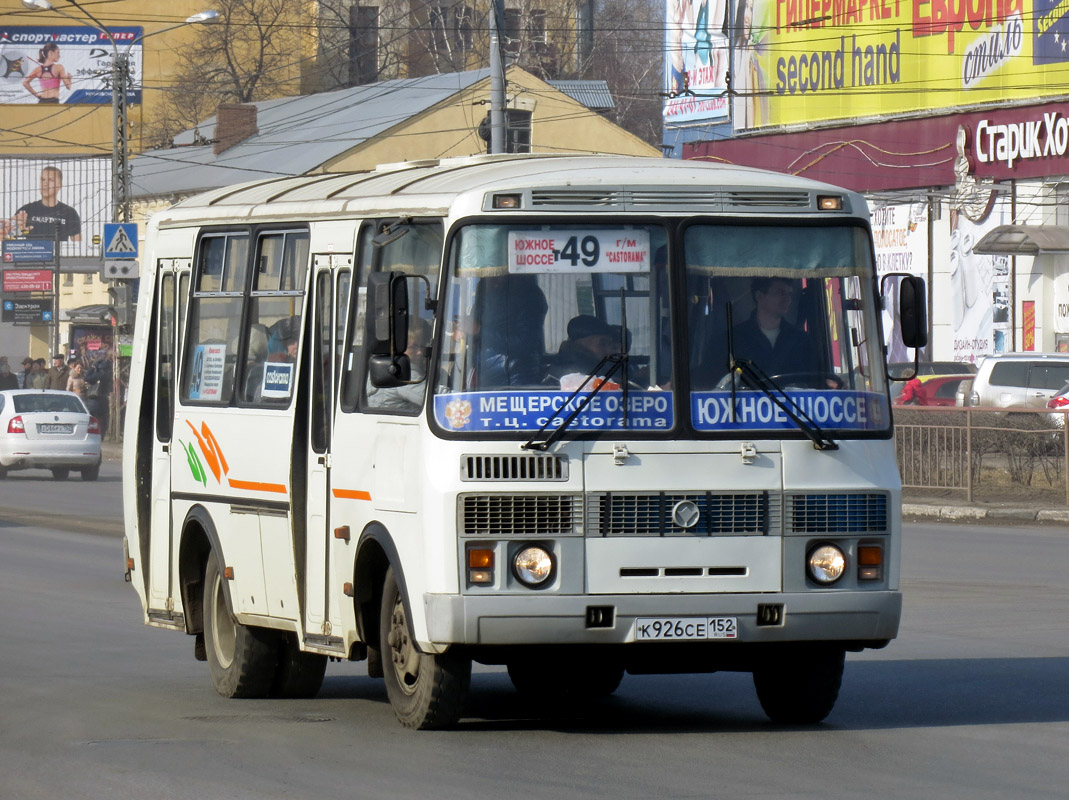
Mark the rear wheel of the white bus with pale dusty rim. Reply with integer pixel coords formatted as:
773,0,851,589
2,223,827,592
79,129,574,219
203,555,278,697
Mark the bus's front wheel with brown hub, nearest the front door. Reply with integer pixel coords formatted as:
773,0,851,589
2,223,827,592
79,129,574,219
378,567,471,730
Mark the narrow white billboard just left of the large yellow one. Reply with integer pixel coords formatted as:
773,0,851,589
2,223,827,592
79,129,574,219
664,0,729,125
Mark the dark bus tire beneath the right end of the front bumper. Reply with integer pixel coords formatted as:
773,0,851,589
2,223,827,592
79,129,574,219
754,646,846,725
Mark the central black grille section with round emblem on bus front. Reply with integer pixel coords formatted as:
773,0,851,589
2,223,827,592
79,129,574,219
587,492,780,537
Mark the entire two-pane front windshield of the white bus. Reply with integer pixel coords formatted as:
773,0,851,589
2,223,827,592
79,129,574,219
433,222,889,436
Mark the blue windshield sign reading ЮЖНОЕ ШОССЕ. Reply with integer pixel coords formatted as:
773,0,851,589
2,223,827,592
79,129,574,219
691,390,890,431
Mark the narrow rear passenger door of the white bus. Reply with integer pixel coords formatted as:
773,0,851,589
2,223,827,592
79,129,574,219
148,259,189,619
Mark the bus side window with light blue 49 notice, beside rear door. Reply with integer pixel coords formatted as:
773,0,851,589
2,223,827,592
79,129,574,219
182,233,249,405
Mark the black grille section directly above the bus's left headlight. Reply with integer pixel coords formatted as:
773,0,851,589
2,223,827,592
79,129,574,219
459,494,583,536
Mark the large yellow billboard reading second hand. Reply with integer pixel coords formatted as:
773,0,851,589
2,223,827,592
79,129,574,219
732,0,1069,129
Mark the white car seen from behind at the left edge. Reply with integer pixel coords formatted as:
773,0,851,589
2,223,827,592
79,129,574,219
0,389,100,480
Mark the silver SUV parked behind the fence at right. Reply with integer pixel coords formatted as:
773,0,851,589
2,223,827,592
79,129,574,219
964,353,1069,409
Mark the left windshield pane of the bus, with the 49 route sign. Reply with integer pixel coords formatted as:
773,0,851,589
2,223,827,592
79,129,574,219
434,224,675,432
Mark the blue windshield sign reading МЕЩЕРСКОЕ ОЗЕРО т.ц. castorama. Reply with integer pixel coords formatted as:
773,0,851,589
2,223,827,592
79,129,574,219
434,389,673,432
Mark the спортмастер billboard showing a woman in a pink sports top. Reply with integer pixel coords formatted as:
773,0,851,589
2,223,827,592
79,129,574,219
0,26,142,105
